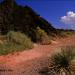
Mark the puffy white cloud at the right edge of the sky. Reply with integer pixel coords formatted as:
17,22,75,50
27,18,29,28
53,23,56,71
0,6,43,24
61,11,75,27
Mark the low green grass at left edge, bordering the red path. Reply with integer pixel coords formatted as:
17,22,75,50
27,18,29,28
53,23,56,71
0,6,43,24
0,43,29,55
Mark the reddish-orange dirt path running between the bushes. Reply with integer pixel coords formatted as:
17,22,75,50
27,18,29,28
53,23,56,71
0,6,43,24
0,35,75,75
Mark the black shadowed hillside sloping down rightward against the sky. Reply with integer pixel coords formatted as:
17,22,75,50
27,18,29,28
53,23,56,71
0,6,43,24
0,0,56,41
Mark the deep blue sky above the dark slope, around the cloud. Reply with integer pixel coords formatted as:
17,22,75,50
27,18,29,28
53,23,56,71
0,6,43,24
0,0,75,29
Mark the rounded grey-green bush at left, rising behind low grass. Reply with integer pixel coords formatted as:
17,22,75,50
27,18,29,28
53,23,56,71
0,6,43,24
7,31,33,48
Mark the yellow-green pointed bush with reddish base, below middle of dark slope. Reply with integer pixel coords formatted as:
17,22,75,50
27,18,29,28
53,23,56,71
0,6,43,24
36,27,51,44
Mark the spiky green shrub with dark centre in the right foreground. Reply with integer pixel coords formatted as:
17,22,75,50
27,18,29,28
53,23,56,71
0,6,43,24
51,46,75,75
